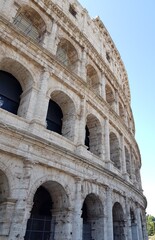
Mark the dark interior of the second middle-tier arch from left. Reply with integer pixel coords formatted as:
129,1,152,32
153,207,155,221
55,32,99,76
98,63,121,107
46,99,63,134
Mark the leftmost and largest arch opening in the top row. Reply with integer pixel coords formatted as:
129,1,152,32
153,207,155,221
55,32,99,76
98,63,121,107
13,5,46,43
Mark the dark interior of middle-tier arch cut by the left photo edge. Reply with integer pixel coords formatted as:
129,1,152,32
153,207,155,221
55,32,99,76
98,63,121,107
0,70,22,114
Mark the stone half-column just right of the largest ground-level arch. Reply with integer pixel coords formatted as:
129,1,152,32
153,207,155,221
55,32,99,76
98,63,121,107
72,178,83,240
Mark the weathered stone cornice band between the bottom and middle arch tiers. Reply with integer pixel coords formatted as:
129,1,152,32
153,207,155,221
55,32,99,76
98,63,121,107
0,123,146,207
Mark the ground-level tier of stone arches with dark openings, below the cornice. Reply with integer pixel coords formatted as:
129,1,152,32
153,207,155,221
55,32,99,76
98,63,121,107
0,163,147,240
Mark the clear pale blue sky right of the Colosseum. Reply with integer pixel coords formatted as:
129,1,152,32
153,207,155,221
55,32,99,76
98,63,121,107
79,0,155,216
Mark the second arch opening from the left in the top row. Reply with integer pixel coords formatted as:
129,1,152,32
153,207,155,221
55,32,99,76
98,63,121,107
56,38,78,73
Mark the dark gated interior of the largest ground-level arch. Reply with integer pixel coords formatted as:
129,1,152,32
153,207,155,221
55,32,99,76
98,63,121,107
24,186,54,240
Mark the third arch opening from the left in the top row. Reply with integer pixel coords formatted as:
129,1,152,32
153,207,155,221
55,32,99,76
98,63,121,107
86,64,100,94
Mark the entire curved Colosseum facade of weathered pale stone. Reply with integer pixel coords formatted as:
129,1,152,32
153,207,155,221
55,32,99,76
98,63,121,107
0,0,147,240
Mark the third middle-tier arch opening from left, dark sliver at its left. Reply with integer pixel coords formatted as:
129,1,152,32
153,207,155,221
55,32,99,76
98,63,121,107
85,114,102,157
